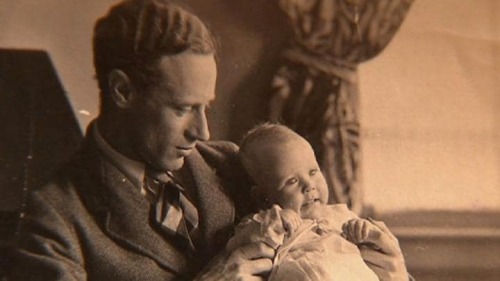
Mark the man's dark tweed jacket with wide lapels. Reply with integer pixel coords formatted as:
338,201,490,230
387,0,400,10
9,130,248,280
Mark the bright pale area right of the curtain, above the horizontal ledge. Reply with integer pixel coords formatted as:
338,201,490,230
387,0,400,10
361,0,500,211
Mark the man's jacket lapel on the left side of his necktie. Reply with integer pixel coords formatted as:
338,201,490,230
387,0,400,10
80,135,189,274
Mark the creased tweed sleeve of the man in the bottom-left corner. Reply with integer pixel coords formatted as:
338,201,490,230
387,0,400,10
7,189,87,280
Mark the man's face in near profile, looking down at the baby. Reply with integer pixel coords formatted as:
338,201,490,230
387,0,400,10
126,53,217,171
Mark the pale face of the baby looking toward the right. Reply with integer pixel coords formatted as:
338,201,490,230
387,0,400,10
256,136,328,218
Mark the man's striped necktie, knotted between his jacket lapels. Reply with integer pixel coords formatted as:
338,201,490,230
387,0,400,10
146,168,199,250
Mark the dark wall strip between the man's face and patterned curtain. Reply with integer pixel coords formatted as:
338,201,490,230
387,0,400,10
174,0,288,142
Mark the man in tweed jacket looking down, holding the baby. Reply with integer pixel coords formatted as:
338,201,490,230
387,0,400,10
10,0,412,280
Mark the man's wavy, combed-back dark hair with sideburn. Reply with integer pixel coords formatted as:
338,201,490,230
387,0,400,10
93,0,216,111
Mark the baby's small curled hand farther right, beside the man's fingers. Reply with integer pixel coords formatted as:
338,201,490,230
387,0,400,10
341,218,380,245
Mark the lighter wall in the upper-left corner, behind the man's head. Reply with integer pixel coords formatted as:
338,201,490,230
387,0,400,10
0,0,116,128
